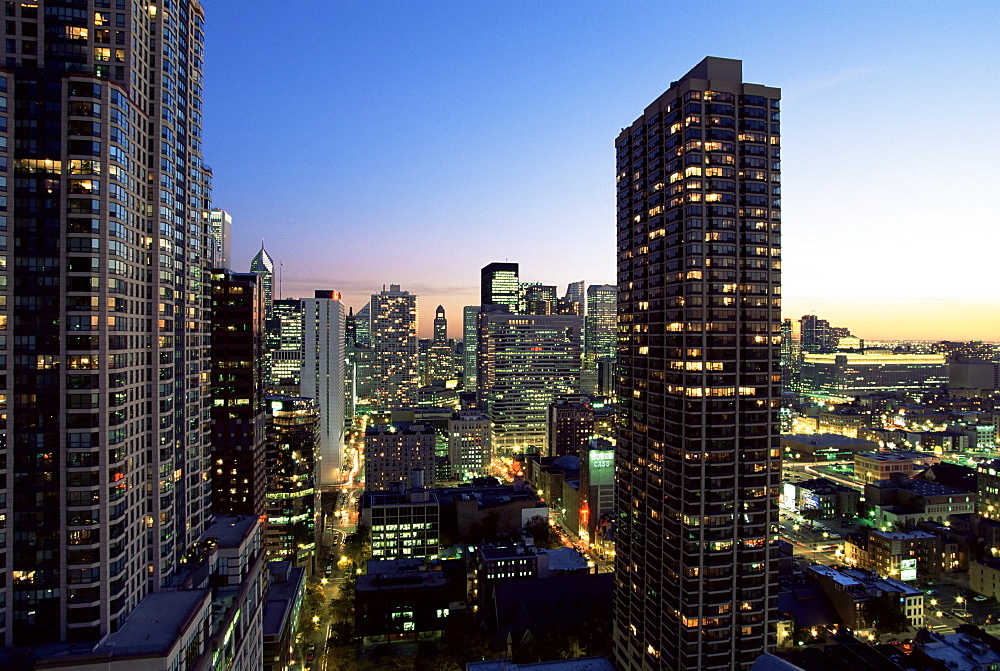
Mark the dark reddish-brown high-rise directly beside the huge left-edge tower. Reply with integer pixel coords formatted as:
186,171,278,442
210,270,266,516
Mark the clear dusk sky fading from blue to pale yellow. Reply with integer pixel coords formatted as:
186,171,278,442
203,0,1000,340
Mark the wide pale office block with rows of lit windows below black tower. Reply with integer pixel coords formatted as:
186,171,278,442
477,307,583,456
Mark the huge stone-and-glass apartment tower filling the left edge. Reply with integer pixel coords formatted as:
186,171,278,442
0,0,213,645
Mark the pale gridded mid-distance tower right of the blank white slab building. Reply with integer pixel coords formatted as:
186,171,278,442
369,284,419,409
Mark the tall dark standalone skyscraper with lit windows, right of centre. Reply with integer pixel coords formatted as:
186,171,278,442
614,57,781,671
